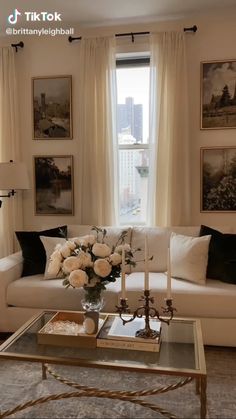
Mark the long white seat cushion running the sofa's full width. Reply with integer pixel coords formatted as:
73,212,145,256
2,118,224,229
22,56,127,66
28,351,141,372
6,272,236,319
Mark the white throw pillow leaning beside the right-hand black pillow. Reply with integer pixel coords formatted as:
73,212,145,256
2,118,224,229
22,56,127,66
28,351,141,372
170,233,211,284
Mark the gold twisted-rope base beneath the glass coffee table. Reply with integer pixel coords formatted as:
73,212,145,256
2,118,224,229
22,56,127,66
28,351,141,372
0,364,206,419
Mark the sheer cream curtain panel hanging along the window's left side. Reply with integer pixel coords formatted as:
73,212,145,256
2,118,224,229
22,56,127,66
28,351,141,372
78,37,118,225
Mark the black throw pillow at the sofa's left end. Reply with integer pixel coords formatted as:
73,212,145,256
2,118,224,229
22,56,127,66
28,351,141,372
15,225,67,276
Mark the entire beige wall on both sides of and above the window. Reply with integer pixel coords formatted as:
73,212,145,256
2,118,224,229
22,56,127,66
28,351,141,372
0,13,236,229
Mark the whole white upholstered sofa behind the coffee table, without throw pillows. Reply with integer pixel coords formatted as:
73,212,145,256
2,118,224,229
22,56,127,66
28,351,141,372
0,225,236,347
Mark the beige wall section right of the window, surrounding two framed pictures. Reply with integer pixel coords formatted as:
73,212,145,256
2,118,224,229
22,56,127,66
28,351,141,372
188,15,236,226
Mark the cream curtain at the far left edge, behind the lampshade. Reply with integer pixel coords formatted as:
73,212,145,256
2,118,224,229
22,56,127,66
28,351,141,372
0,47,23,257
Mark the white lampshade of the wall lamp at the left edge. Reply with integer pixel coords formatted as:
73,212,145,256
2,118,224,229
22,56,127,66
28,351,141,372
0,162,30,190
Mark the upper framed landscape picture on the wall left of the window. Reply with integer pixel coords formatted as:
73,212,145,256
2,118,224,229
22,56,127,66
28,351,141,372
32,76,72,140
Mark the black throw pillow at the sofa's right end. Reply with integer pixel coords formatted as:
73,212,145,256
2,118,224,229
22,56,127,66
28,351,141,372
199,225,236,284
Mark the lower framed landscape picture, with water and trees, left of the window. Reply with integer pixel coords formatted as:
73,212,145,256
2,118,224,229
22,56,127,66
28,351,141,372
34,156,74,215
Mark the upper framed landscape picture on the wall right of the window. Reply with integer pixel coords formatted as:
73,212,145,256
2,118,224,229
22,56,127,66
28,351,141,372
201,59,236,129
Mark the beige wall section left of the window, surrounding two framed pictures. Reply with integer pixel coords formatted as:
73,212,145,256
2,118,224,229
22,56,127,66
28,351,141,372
17,37,80,229
